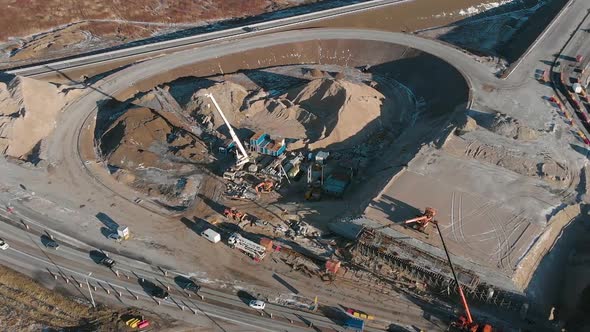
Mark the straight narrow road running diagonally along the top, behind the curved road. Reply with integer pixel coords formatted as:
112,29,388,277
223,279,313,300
7,0,413,76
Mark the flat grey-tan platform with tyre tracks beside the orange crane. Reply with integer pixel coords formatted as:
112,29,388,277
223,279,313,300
365,148,560,288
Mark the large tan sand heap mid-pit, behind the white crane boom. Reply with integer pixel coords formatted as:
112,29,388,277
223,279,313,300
187,78,384,149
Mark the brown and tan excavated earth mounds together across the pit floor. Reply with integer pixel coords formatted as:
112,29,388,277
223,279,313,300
95,66,414,207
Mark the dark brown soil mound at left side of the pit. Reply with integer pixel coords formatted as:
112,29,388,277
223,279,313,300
100,107,208,170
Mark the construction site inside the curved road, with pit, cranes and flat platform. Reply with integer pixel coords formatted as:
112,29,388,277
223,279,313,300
76,33,579,326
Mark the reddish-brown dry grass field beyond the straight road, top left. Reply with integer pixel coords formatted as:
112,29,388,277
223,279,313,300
0,0,318,65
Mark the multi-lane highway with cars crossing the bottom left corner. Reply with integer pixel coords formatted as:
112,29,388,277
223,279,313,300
0,212,384,331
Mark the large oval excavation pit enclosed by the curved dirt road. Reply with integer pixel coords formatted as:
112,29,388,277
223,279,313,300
93,40,469,211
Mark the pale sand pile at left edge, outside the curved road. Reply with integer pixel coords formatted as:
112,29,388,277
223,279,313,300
0,77,67,158
